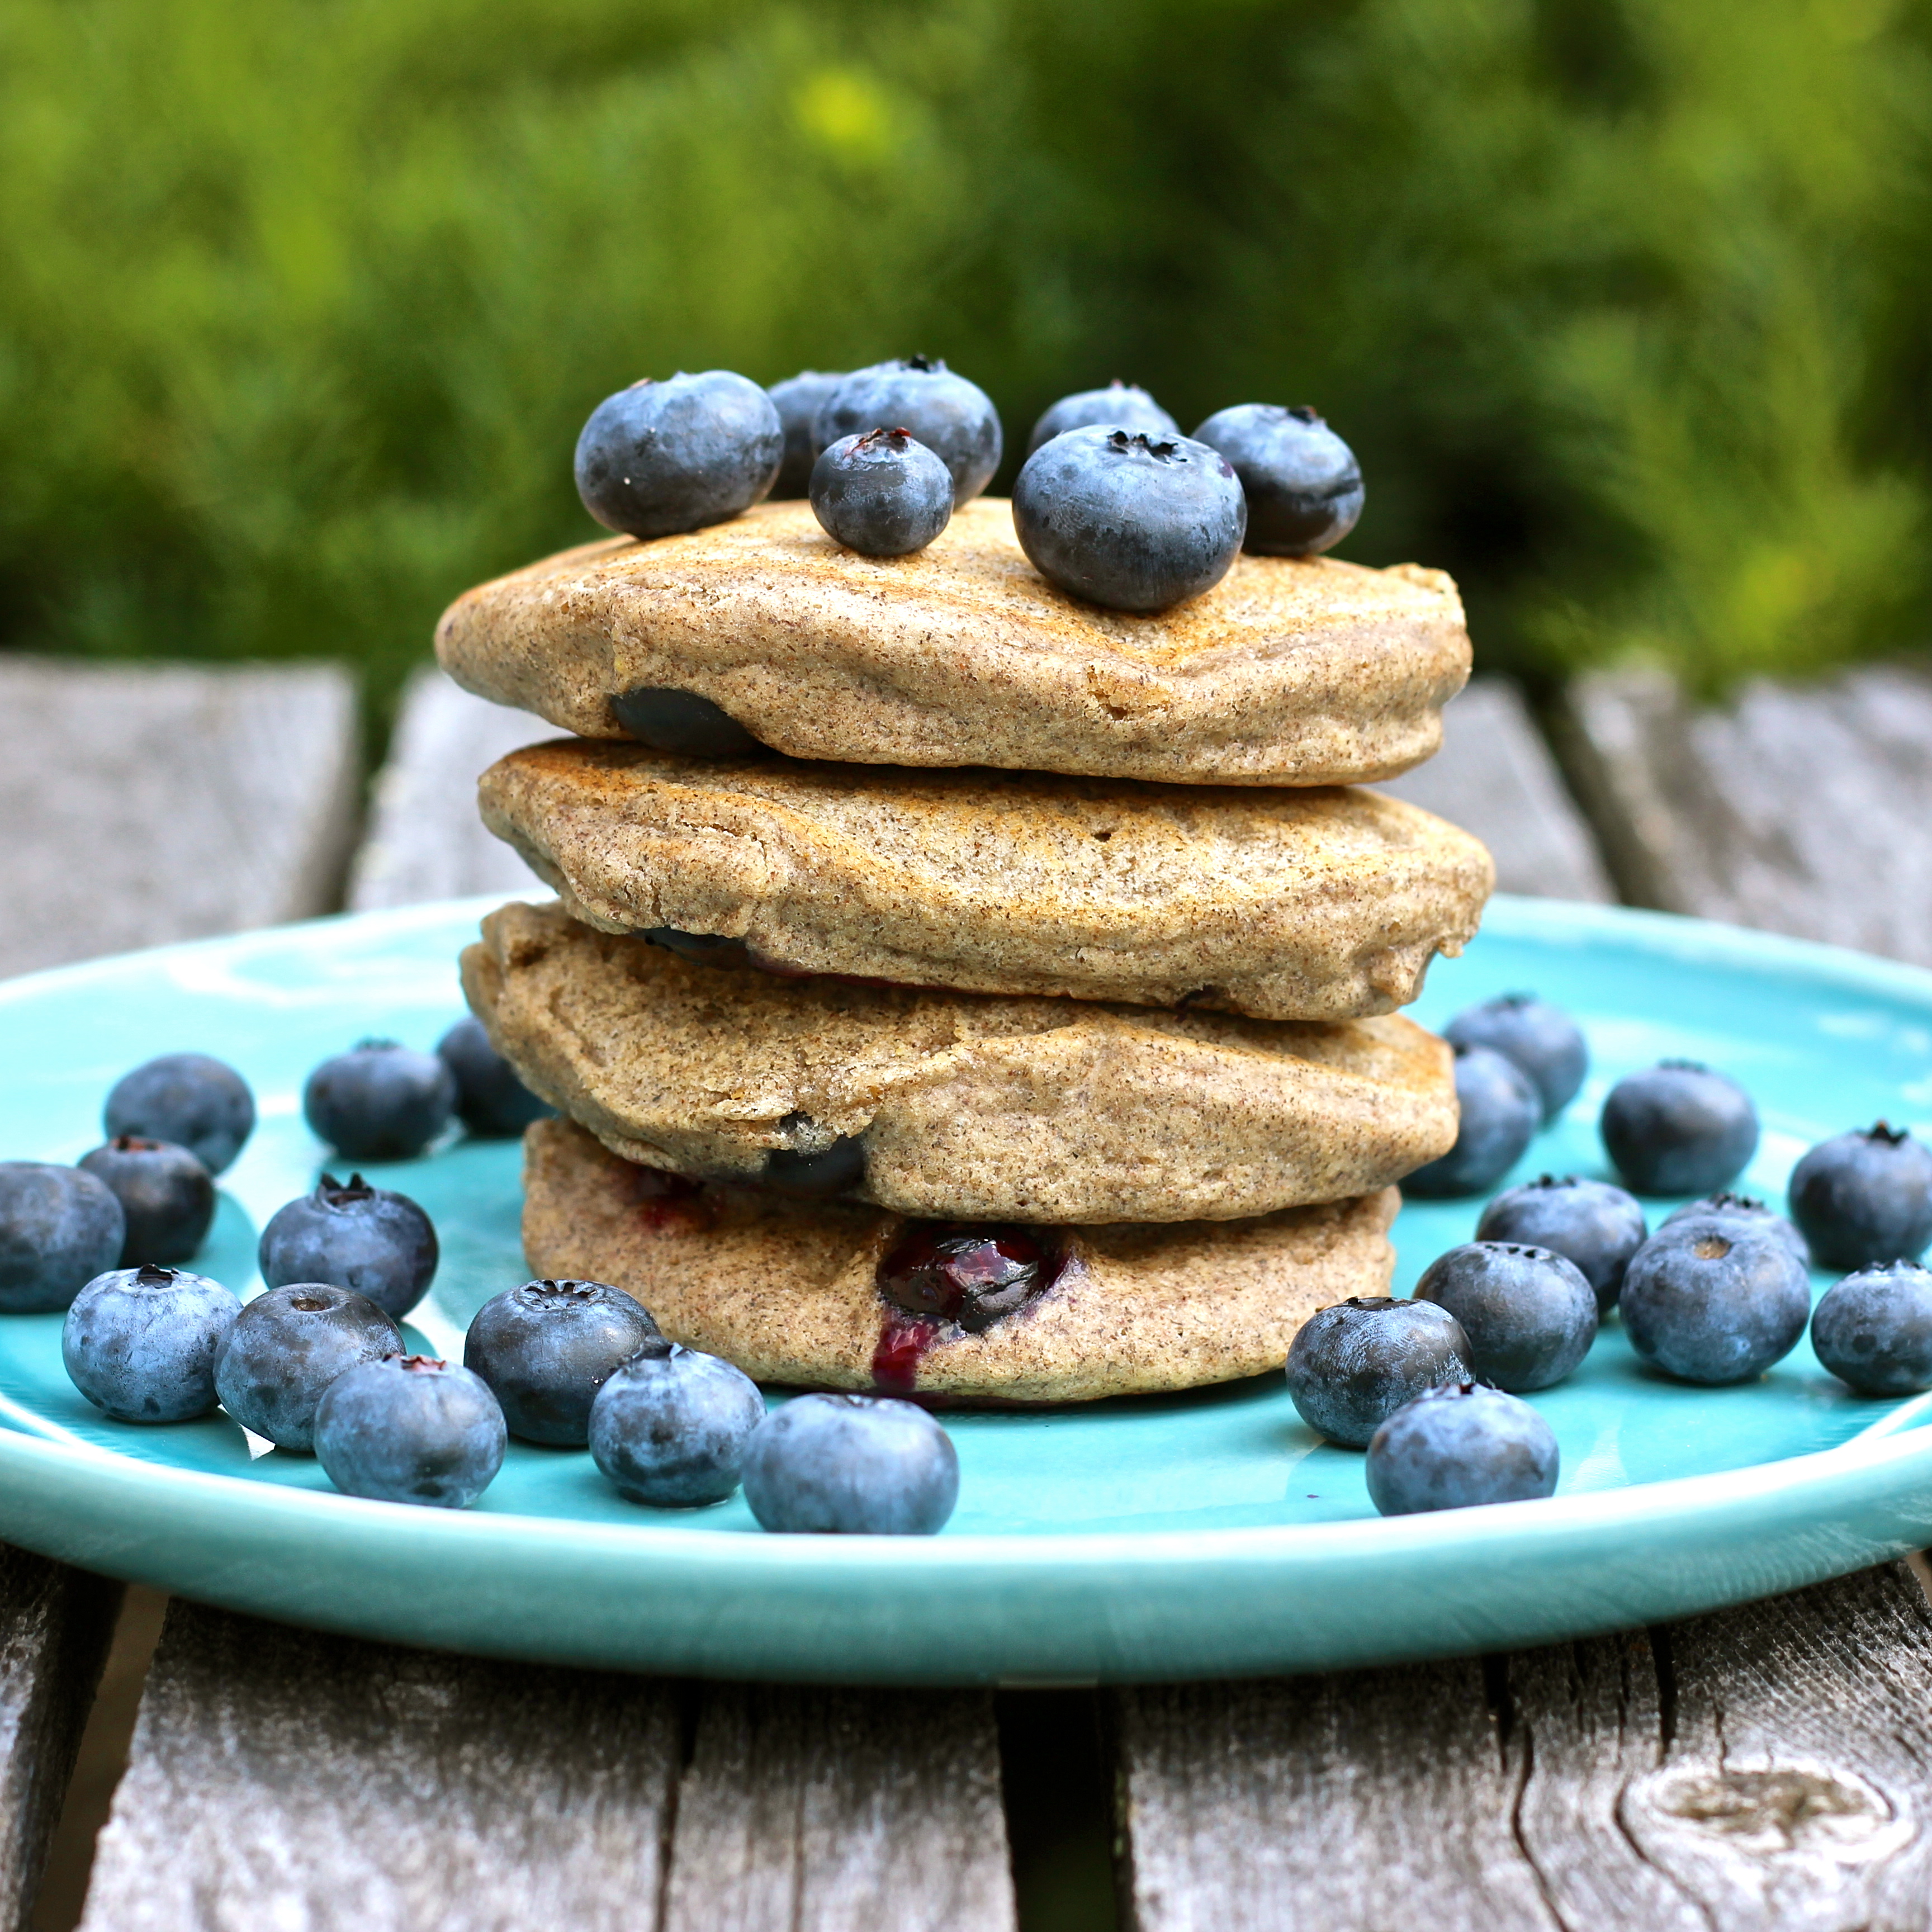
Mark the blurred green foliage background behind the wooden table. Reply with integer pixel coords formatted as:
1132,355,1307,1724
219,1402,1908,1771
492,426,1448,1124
0,0,1932,711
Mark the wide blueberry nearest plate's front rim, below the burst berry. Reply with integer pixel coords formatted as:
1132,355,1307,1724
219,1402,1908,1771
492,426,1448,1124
744,1395,960,1536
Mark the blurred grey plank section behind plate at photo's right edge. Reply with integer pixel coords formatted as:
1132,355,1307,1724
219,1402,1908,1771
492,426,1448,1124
1559,666,1932,964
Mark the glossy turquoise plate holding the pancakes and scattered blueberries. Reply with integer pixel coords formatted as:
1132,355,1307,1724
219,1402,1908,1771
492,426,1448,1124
0,898,1932,1683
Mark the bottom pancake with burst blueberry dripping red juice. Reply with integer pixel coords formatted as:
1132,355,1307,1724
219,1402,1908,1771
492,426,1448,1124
524,1119,1399,1405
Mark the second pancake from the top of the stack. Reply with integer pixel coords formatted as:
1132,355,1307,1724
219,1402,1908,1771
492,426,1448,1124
479,738,1495,1020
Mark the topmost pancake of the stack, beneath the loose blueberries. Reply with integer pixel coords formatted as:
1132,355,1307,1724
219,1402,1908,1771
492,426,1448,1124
437,496,1470,784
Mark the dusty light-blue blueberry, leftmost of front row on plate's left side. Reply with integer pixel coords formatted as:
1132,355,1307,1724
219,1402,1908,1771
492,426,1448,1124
60,1263,242,1422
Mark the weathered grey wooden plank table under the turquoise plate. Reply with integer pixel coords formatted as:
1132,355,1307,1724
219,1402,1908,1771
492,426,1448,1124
0,662,1932,1932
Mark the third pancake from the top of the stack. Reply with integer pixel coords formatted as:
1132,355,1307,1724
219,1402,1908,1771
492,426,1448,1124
462,904,1457,1223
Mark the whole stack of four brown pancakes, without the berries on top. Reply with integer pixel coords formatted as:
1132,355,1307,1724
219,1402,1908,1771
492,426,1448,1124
437,499,1493,1403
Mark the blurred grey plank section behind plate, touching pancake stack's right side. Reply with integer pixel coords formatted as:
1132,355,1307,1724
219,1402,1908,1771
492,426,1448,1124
1380,678,1617,900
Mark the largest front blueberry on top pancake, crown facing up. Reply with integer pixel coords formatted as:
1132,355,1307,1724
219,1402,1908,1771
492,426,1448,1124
1012,423,1248,610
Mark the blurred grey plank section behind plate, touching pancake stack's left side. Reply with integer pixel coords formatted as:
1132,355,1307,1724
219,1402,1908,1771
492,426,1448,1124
348,669,556,912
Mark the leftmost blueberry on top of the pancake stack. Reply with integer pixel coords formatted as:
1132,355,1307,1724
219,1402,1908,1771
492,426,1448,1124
577,369,784,537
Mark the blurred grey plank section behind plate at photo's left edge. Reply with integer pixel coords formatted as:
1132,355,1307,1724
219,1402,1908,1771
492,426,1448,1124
0,657,357,974
